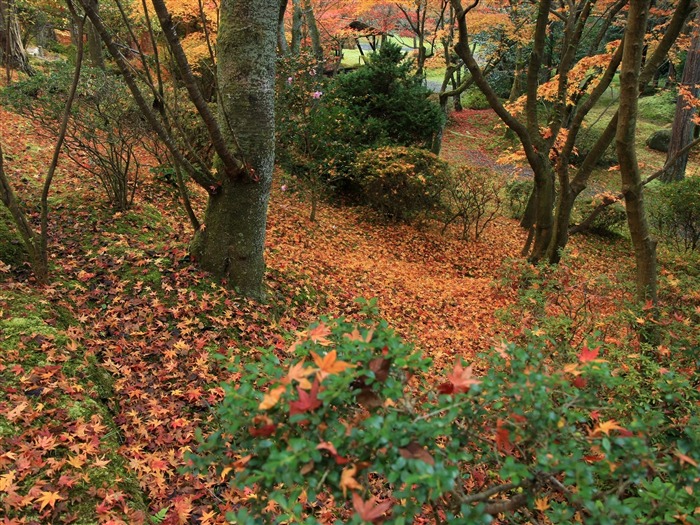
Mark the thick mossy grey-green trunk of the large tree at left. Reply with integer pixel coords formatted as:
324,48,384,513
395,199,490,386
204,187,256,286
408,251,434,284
192,0,279,299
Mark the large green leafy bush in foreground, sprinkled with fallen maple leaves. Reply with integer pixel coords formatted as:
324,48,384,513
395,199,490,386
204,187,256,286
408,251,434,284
192,298,700,525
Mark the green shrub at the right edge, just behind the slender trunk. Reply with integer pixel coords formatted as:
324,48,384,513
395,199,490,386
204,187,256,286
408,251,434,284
647,177,700,252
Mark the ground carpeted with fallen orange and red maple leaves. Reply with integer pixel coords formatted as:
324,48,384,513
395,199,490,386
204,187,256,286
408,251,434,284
0,99,698,524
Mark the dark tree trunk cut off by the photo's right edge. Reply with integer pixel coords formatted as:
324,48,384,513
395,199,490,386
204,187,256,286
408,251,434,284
661,11,700,182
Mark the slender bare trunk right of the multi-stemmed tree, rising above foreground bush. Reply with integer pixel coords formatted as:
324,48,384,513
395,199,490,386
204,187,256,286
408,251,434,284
615,0,656,303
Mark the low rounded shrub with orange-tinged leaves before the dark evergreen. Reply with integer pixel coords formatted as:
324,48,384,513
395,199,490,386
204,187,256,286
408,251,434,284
353,146,449,222
